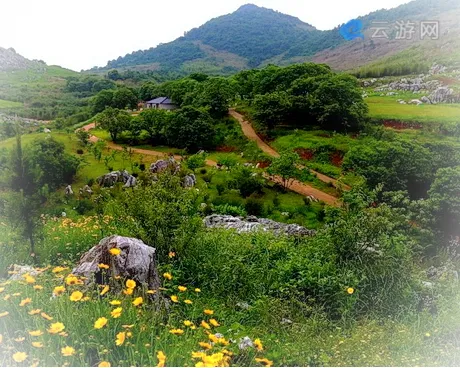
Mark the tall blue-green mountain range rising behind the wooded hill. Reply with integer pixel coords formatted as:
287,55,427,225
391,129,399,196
93,0,460,73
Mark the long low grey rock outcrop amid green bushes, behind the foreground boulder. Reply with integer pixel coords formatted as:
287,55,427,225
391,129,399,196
203,215,316,236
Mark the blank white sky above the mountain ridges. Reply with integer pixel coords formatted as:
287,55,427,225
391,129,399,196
0,0,408,71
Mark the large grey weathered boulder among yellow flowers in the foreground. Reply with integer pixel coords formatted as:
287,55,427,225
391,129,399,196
72,235,160,290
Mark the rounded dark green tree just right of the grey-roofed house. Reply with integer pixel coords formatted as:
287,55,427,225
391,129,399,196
165,106,215,152
